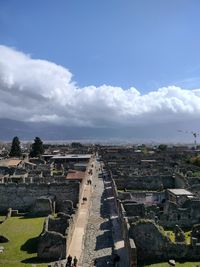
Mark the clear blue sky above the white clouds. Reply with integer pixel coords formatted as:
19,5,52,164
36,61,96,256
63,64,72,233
0,0,200,93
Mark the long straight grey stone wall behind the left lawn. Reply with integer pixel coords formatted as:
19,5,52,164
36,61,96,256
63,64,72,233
0,182,80,212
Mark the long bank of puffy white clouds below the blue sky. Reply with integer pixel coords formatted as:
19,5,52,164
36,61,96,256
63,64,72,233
0,46,200,127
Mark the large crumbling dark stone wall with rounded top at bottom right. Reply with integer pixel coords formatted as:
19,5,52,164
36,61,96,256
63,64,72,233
129,220,200,262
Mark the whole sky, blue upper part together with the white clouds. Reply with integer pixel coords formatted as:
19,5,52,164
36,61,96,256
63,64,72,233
0,0,200,142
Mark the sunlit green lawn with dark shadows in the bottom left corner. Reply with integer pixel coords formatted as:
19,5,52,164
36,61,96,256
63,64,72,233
0,217,47,267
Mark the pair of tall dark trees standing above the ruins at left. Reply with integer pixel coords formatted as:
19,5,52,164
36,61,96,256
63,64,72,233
9,136,44,158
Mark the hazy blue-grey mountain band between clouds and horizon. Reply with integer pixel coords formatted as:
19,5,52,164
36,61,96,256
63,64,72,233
0,118,198,143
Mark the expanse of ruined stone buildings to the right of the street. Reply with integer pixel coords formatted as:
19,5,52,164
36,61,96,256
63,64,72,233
99,147,200,266
